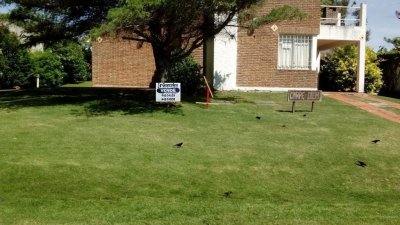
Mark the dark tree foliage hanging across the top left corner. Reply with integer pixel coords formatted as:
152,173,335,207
0,0,119,45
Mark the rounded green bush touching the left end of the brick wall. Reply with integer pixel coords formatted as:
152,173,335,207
49,41,91,83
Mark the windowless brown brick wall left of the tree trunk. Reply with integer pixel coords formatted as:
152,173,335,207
92,39,155,87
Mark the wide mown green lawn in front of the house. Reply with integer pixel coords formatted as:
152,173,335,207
0,88,400,225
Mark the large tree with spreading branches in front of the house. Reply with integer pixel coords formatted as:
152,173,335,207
93,0,305,84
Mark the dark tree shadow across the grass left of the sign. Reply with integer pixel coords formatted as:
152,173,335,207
0,87,183,117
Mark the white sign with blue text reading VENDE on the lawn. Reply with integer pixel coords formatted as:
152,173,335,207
156,83,181,102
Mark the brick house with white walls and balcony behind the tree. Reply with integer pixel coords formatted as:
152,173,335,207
93,0,366,92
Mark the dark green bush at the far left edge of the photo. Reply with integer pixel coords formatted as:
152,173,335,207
0,26,31,88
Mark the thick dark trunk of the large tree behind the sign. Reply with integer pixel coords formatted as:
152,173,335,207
150,45,172,88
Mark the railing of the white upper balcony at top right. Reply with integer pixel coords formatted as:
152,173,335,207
321,5,363,26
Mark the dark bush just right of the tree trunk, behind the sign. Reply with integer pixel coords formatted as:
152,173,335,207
167,56,202,95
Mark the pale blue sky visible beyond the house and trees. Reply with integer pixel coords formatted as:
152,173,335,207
0,0,400,50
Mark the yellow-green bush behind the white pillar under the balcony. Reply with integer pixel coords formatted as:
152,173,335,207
319,45,383,92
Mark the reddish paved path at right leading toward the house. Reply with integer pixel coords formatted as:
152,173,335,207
324,92,400,123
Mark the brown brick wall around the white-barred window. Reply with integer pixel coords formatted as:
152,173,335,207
237,0,320,88
